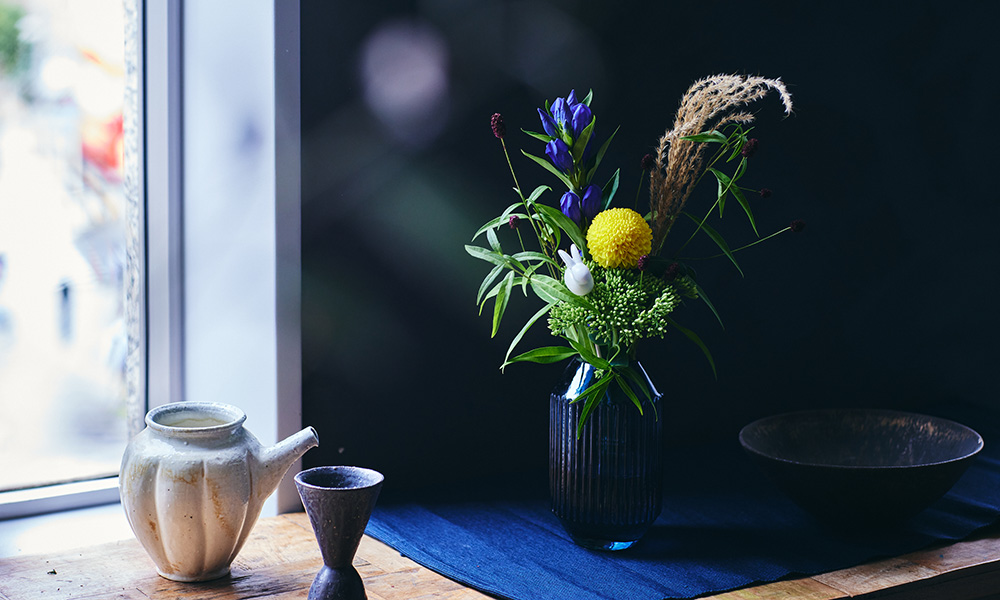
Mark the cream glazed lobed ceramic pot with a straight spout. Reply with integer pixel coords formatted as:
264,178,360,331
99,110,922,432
119,402,319,581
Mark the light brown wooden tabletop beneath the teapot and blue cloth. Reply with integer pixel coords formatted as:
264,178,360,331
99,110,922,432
0,513,1000,600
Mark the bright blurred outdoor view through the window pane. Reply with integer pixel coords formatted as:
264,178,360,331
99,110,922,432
0,0,126,491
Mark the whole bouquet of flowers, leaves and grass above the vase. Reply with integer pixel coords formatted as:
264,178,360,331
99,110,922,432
465,75,804,431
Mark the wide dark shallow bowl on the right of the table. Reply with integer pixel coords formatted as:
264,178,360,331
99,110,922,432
740,409,983,527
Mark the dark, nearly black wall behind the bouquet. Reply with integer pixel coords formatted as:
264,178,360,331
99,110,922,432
302,0,1000,488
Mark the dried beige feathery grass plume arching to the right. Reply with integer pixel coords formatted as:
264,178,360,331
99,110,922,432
649,75,792,250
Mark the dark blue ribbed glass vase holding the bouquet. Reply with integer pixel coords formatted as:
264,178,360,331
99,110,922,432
549,359,663,550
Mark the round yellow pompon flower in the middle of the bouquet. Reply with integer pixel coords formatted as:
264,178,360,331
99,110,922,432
587,208,653,269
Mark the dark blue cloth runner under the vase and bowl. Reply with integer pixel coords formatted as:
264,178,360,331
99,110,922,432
367,406,1000,600
